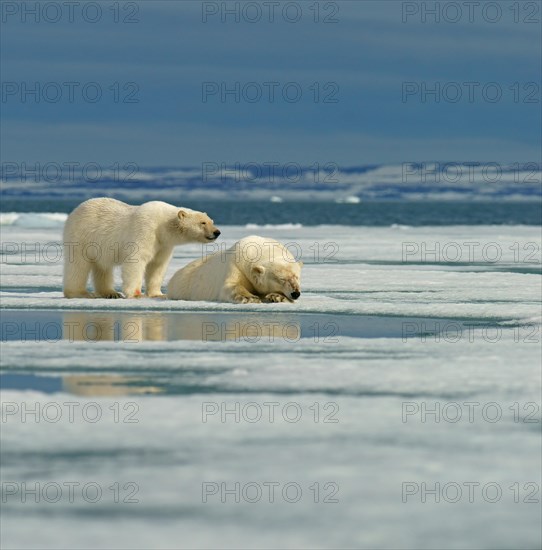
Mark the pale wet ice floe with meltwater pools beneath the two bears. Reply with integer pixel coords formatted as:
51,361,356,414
1,224,541,549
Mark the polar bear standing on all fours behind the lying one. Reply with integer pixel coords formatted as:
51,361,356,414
64,197,220,298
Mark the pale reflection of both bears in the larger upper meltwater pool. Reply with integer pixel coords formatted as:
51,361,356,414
62,311,301,343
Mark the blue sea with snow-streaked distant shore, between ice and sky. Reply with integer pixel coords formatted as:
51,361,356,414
0,162,542,226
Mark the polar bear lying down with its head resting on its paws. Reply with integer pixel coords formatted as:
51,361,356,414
167,235,303,304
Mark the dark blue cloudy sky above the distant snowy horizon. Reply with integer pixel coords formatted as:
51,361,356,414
0,0,542,167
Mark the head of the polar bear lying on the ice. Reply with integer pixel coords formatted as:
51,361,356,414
250,262,303,300
